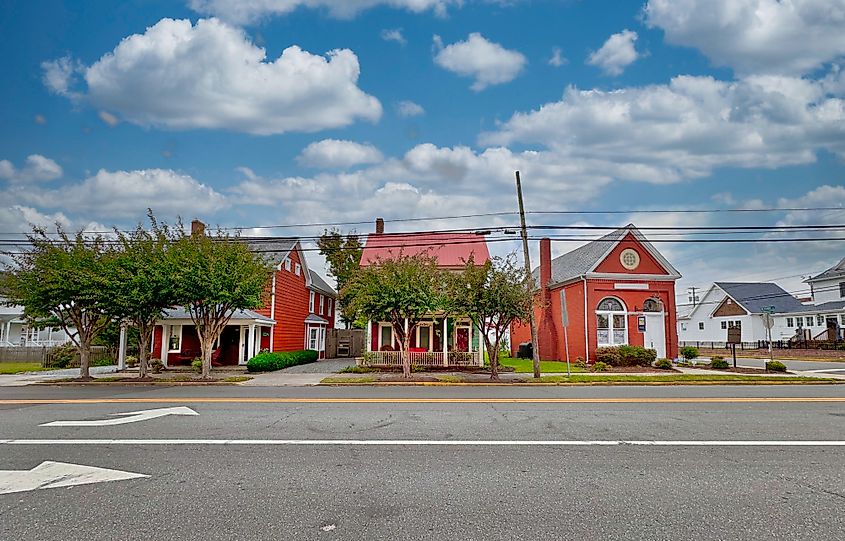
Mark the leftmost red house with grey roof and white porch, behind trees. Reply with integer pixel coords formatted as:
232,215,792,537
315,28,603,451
152,237,337,366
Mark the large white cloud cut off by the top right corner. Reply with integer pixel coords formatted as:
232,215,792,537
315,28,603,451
645,0,845,75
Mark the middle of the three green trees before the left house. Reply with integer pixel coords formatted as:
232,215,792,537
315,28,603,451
106,217,178,378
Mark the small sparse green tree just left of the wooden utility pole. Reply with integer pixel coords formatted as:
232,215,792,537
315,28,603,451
448,255,534,380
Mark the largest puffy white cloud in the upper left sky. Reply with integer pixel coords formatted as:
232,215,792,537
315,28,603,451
45,19,382,135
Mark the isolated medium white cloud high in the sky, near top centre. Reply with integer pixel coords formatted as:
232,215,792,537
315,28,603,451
434,32,528,92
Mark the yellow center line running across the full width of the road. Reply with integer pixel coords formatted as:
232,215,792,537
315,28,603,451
0,397,845,405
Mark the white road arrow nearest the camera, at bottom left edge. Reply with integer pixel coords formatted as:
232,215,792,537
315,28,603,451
0,461,149,494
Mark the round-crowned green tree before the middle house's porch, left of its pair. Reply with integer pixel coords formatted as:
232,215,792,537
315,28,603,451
344,254,446,378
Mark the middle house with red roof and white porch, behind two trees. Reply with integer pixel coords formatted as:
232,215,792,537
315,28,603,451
361,219,490,366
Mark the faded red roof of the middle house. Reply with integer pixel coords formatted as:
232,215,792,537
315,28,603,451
361,233,490,268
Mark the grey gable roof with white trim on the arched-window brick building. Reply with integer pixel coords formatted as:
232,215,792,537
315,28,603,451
533,224,681,284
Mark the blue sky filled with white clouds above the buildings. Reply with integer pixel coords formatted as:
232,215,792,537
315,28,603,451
0,0,845,302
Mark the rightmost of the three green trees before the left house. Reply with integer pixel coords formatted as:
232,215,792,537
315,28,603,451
169,226,272,378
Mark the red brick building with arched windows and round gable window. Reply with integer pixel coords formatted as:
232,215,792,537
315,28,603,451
511,224,681,362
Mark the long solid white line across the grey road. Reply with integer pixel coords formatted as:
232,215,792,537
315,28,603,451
0,439,845,447
